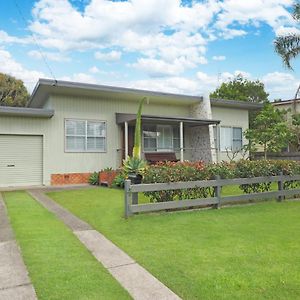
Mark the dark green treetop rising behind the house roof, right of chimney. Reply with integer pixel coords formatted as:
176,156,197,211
210,75,269,103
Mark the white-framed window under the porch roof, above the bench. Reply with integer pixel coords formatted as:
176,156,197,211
143,124,180,152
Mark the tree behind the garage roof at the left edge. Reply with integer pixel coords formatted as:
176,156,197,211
0,73,29,106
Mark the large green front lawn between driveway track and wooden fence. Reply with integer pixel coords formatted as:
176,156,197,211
49,188,300,299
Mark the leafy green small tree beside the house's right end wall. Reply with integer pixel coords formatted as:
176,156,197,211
245,103,292,159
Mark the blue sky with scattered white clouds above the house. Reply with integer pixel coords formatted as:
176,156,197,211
0,0,300,101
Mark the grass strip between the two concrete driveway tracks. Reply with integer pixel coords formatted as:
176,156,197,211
4,192,130,300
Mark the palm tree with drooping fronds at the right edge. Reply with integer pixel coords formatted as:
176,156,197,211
275,3,300,113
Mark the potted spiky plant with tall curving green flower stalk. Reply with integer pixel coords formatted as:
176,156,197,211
123,97,147,184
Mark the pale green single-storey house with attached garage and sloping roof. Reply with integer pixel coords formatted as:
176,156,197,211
0,79,261,187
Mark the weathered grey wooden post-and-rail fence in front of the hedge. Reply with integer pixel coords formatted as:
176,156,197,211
124,175,300,218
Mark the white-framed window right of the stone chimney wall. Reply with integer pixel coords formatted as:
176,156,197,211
214,126,243,151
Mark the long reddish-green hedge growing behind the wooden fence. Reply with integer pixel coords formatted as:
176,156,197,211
143,160,300,202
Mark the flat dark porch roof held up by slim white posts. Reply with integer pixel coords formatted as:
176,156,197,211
116,113,221,126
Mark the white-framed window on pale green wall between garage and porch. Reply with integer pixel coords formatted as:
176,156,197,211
65,119,106,152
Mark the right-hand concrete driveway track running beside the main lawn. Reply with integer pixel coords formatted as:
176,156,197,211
28,190,180,300
